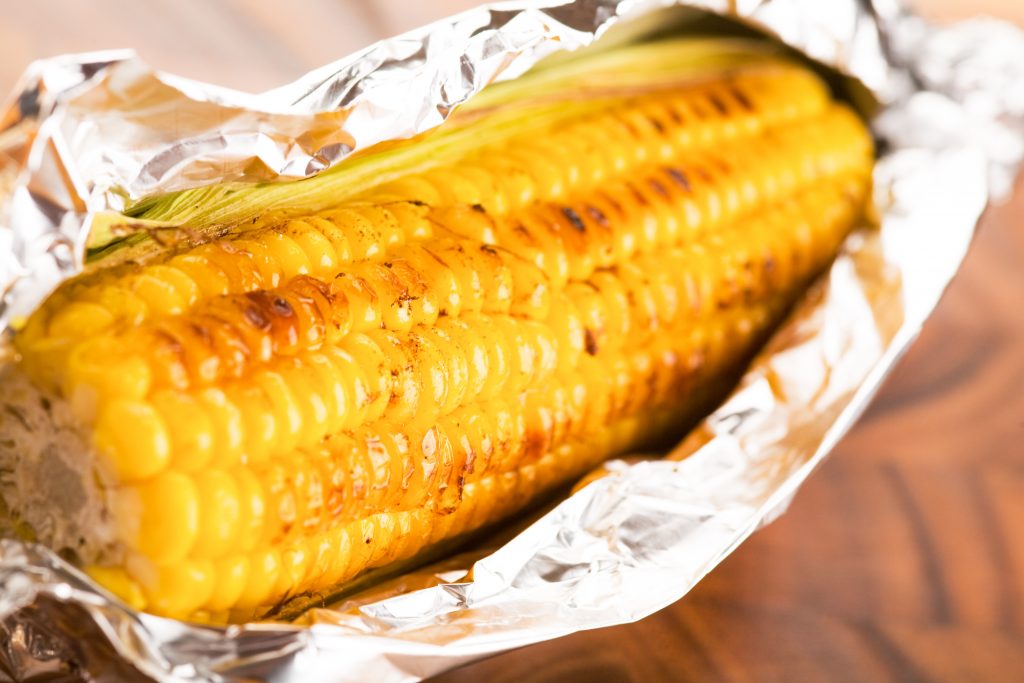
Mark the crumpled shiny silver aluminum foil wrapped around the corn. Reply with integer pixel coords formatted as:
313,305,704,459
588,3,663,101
0,0,1024,683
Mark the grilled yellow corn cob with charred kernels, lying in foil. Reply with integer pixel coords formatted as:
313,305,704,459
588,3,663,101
0,48,872,621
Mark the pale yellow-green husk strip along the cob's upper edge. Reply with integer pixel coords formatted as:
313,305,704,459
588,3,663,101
88,38,781,262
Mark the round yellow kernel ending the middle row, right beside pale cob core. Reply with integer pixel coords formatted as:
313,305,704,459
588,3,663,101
93,398,171,481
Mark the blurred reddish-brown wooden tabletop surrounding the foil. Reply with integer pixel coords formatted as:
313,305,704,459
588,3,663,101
0,0,1024,683
